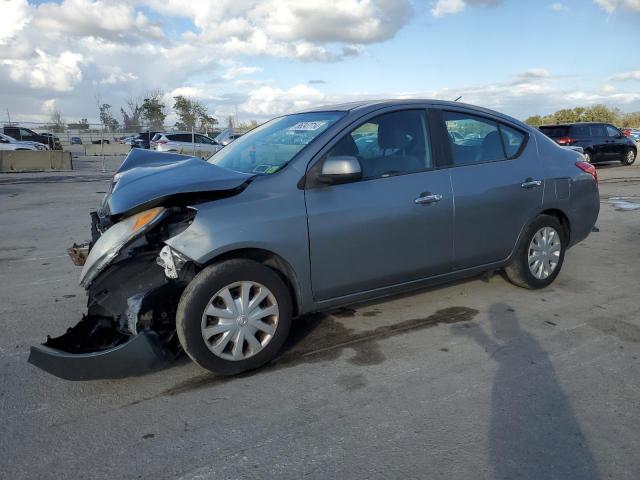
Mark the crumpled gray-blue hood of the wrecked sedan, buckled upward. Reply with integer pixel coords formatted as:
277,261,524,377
103,148,254,215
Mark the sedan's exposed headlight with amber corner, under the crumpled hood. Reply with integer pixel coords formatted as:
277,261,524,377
80,207,167,288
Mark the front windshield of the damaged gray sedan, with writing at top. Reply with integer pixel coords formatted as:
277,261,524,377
209,112,344,175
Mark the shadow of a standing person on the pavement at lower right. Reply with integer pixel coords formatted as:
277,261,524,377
451,303,602,480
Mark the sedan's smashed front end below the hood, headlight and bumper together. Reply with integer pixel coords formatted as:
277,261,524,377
29,207,196,380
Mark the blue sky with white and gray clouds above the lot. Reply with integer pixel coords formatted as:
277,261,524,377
0,0,640,125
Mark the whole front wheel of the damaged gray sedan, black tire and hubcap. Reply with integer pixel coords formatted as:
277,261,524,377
176,259,292,375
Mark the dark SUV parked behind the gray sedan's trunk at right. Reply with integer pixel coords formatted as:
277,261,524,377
540,123,637,165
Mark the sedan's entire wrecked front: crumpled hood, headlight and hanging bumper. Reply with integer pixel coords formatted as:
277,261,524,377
29,149,253,380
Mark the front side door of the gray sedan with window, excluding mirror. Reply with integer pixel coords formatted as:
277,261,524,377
305,109,453,300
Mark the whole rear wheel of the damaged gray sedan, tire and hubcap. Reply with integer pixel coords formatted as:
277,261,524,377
505,215,567,289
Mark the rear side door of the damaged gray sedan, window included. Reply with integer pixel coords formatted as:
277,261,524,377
441,109,544,270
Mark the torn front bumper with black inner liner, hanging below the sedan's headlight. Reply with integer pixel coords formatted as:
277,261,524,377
28,240,185,380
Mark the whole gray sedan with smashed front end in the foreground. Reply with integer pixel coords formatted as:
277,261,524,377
29,100,600,379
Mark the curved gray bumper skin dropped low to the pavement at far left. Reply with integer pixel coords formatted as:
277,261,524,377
29,332,169,380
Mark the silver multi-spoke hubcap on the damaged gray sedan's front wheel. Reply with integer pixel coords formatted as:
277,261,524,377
202,281,279,361
